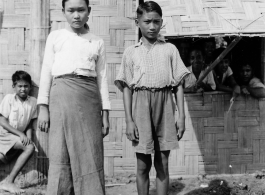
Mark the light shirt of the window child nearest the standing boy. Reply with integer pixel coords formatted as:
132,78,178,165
184,66,216,90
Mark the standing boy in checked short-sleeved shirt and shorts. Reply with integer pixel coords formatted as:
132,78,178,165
115,1,189,195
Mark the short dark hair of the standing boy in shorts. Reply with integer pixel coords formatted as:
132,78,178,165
136,1,162,18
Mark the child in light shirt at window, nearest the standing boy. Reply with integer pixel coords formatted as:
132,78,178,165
184,48,216,93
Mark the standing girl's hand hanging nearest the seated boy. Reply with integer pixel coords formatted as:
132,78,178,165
37,105,49,133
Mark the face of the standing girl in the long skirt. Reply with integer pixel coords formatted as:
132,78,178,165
63,0,90,29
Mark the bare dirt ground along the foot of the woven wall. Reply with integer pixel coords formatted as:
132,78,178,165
0,171,265,195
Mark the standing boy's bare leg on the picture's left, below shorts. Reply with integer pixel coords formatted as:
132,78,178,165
136,153,152,195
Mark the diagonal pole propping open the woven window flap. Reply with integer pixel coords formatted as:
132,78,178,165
196,37,242,84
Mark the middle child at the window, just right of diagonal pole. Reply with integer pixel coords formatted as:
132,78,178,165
213,48,240,95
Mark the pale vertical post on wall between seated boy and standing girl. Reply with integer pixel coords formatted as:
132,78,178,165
29,0,50,93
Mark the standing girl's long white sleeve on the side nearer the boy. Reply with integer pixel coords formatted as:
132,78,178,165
96,40,111,110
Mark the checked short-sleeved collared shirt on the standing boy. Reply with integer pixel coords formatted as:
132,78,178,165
115,36,189,91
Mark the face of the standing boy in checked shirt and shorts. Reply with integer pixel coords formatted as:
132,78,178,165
135,12,163,40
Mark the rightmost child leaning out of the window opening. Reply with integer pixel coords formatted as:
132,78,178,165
236,62,265,98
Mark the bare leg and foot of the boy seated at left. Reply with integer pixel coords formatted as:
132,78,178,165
0,142,34,194
